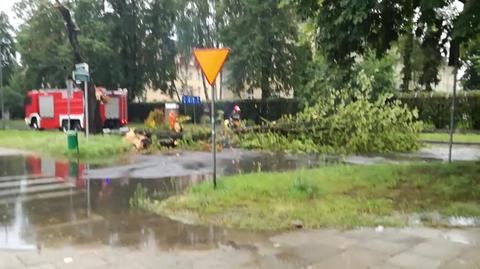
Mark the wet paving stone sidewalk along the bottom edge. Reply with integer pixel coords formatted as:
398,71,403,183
0,228,480,269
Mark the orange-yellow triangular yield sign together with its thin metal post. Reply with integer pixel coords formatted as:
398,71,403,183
193,49,230,188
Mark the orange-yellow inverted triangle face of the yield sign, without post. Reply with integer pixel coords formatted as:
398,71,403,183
193,49,230,86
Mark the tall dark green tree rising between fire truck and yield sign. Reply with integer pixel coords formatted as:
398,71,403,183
107,0,176,100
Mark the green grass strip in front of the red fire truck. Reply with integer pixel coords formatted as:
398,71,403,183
0,130,130,163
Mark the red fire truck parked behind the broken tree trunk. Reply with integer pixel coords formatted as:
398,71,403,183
25,88,128,130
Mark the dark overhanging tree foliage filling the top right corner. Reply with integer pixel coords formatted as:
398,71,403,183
290,0,480,89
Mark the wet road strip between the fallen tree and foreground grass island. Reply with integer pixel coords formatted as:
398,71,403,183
87,145,480,179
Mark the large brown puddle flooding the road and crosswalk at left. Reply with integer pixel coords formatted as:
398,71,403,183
0,153,318,250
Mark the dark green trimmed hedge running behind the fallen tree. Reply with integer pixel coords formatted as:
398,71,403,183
129,91,480,130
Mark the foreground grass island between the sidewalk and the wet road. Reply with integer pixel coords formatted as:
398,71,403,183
153,163,480,230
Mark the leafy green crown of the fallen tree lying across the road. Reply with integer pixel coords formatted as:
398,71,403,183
235,74,422,153
